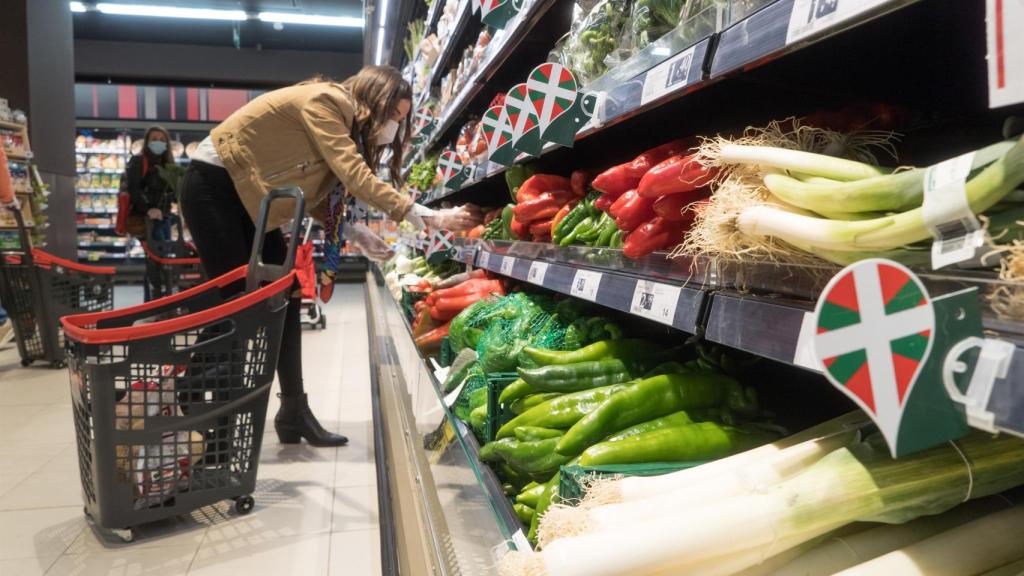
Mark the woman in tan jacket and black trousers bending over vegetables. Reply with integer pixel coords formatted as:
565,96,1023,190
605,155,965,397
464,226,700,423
181,67,482,446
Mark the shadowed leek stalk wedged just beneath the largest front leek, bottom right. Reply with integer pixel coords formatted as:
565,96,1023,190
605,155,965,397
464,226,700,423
772,496,1013,576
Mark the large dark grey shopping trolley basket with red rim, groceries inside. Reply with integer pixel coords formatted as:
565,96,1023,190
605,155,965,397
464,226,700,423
61,189,303,541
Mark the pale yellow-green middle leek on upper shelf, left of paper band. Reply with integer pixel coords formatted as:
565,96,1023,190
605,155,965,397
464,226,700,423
764,169,925,214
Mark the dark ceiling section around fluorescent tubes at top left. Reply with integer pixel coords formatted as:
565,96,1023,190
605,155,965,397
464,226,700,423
75,0,362,52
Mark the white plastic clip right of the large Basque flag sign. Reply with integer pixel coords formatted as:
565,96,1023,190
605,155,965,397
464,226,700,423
942,336,1014,434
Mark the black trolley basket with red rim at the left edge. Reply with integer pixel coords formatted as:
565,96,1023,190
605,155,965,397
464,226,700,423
0,206,115,368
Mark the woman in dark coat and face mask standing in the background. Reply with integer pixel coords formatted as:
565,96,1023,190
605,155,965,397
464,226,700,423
121,126,175,301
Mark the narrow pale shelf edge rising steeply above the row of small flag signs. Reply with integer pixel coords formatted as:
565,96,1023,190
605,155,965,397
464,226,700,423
421,0,556,156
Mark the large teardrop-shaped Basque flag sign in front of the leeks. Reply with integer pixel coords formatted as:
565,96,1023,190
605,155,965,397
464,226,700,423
814,258,935,454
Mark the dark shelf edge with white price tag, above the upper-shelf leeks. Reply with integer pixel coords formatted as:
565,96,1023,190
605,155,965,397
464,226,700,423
711,0,920,78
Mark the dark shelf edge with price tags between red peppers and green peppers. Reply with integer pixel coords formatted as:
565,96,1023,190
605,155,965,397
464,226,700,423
451,240,1024,436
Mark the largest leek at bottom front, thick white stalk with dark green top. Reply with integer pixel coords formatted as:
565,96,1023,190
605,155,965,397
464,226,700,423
502,433,1024,576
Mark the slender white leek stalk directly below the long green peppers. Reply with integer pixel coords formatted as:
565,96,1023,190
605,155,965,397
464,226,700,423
583,410,870,507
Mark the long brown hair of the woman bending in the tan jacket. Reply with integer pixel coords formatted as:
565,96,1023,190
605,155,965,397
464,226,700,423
342,66,413,188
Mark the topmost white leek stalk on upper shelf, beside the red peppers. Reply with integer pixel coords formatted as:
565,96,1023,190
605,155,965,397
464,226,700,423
718,143,886,180
